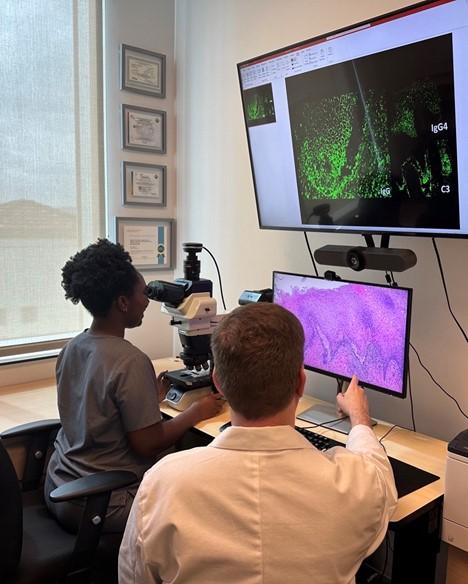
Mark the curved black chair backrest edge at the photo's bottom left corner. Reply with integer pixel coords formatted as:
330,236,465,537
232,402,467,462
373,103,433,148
0,439,23,582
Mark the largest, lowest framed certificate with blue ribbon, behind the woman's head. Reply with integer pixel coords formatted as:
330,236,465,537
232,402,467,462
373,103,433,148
115,217,175,272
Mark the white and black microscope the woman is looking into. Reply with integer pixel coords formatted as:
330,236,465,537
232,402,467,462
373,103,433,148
146,243,221,411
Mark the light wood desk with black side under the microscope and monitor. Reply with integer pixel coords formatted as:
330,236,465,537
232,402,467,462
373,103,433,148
0,359,447,584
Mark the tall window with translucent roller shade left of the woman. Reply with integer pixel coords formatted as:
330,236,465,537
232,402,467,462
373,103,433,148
0,0,104,359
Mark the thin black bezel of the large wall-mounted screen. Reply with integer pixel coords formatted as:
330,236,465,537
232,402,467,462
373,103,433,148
237,0,468,239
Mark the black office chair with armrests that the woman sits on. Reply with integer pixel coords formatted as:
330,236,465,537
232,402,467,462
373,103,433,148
0,420,137,584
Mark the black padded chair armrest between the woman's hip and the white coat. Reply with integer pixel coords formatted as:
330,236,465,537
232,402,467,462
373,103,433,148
49,470,138,503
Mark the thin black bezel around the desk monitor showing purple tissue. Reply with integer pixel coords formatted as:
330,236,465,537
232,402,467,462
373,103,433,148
272,270,413,399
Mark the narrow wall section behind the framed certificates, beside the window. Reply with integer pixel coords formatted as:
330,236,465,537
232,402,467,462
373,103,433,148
104,0,176,359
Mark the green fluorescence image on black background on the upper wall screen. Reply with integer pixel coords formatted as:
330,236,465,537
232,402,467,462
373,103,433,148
286,34,460,229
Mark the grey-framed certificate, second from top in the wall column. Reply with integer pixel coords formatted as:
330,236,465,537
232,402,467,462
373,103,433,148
122,103,166,154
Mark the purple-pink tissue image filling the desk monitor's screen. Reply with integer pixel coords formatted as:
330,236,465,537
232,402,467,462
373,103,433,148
274,273,408,393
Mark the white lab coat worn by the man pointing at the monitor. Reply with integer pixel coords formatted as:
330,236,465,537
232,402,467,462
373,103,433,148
119,426,397,584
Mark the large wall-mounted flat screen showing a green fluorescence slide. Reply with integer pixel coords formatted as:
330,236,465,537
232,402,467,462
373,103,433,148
238,0,468,237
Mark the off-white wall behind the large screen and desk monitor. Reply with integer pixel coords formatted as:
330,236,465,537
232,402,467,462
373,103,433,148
176,0,468,439
